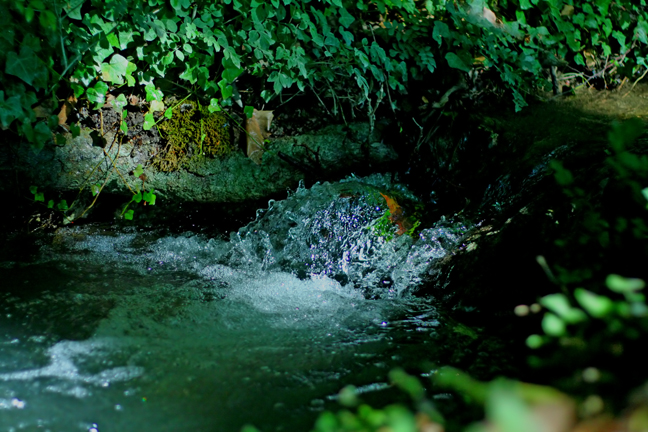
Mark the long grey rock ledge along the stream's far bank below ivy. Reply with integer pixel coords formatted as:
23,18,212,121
0,123,397,202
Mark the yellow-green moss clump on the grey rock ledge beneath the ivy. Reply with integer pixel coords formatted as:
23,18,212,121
153,101,234,172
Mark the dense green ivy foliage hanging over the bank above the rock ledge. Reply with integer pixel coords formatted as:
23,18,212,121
0,0,648,149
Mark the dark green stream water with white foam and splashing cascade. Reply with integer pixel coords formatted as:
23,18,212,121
0,179,466,432
